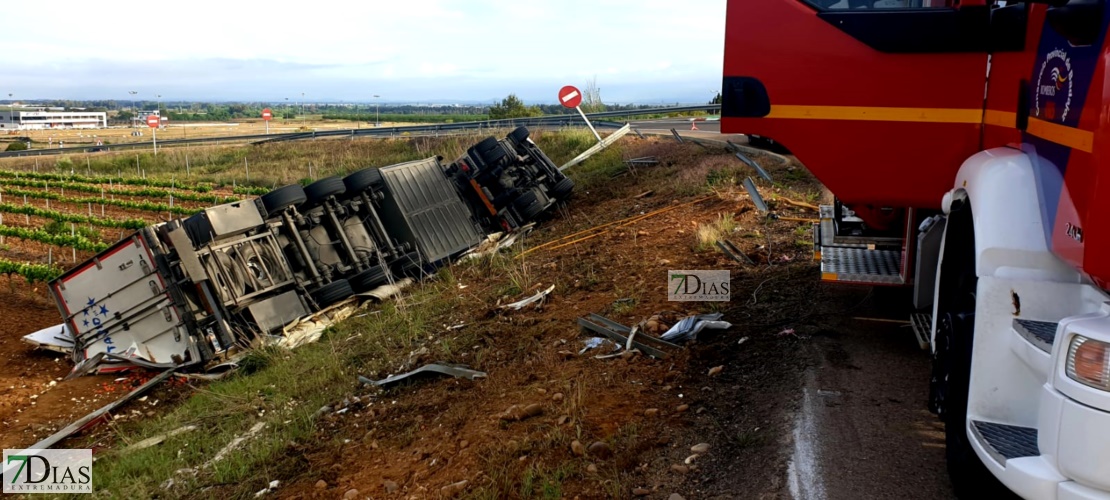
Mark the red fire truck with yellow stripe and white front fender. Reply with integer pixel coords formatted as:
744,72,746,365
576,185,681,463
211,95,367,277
722,0,1110,499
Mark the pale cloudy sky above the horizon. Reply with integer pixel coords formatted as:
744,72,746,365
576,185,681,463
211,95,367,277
0,0,725,103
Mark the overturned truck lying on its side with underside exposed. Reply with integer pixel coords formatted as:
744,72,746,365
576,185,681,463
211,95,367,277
50,127,574,368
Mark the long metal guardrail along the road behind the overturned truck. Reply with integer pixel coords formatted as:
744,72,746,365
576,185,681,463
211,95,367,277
0,104,720,158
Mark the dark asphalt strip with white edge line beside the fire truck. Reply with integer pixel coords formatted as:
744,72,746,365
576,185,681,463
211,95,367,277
790,289,953,500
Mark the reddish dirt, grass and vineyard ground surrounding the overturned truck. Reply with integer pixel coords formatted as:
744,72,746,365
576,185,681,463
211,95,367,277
0,130,936,498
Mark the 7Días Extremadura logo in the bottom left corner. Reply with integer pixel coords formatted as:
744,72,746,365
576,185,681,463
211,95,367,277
3,450,92,493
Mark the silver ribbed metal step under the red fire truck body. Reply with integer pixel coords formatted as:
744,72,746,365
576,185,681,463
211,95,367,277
820,247,906,284
